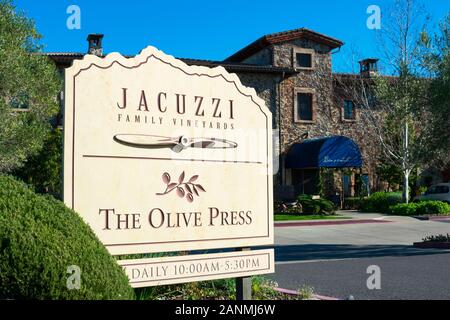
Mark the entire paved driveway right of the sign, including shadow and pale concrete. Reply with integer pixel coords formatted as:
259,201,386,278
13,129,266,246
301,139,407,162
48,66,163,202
271,215,450,300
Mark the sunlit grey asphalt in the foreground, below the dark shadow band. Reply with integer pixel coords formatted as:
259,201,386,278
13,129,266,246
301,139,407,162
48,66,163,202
274,248,450,300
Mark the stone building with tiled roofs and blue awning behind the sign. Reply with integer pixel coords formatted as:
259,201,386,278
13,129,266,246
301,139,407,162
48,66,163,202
47,28,390,199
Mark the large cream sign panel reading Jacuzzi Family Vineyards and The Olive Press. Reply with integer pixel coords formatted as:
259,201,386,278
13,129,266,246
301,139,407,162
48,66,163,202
64,47,273,254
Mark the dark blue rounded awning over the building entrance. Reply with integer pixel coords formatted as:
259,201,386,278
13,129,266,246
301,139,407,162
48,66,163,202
285,136,362,169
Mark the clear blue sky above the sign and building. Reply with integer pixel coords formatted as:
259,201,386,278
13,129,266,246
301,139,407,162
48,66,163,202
15,0,450,71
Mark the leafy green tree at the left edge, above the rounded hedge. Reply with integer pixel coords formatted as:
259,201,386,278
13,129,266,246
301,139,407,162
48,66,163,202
0,0,61,172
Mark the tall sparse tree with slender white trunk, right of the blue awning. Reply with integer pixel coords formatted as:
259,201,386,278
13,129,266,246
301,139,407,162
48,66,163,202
341,0,442,202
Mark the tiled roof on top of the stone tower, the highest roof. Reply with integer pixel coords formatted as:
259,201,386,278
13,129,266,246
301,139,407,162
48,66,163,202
224,28,344,62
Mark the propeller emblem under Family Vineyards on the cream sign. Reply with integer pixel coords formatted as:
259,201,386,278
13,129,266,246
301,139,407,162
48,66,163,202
113,134,238,152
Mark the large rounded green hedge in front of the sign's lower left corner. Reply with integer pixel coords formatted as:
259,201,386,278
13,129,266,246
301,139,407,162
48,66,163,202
0,175,134,299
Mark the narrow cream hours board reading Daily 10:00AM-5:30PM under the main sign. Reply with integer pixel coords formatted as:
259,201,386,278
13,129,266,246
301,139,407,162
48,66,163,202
118,249,275,288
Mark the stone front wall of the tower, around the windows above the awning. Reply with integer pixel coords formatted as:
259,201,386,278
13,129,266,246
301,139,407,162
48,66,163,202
274,40,380,190
